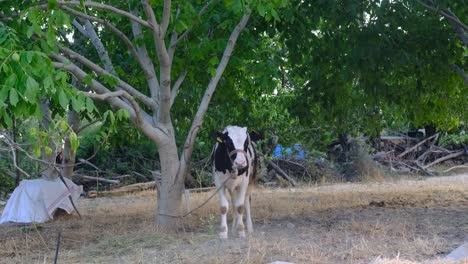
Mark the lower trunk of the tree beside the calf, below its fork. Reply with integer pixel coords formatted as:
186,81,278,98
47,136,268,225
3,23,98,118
155,137,184,230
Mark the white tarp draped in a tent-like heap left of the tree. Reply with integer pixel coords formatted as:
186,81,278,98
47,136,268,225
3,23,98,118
0,178,83,224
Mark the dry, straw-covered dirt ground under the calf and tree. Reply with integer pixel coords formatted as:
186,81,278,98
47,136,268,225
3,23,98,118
0,174,468,264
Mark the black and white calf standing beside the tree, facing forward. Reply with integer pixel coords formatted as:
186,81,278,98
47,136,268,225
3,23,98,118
211,126,261,239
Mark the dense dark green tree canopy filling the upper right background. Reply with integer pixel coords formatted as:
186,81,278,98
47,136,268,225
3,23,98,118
271,0,467,146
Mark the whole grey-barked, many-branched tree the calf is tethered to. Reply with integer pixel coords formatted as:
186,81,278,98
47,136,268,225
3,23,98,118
2,0,286,228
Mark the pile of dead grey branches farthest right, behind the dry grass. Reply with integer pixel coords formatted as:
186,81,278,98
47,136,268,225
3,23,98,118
373,134,468,176
